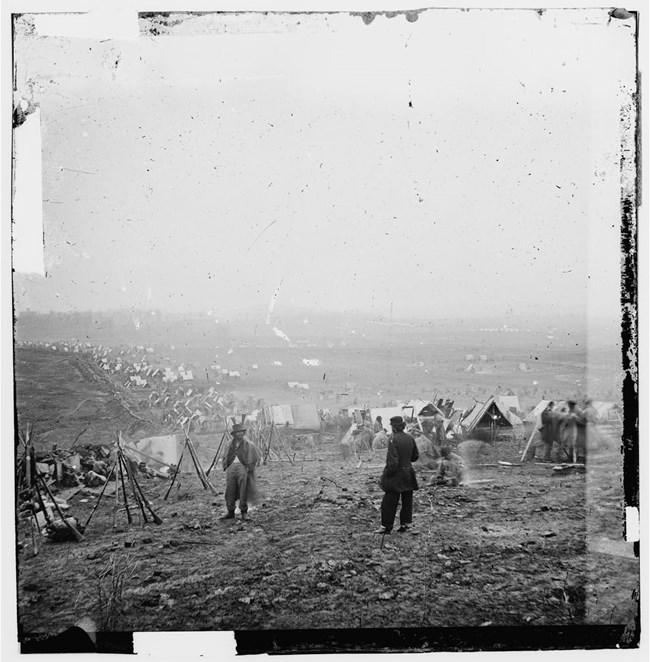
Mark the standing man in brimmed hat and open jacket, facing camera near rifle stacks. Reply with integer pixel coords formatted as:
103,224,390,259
220,423,261,519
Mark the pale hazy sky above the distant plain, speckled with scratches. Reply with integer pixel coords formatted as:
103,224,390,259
15,10,635,316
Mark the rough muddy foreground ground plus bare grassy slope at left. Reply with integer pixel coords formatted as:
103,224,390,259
12,354,639,648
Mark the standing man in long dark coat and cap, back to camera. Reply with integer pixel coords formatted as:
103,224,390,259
377,416,420,533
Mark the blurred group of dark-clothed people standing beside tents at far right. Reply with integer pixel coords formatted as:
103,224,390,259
538,400,597,463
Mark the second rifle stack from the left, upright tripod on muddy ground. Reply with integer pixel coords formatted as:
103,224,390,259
83,432,162,530
